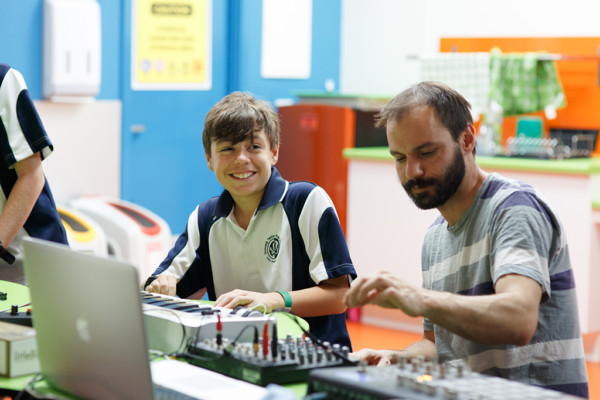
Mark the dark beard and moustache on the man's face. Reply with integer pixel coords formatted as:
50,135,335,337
404,146,465,210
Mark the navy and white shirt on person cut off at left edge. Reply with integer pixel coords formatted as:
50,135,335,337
0,64,67,247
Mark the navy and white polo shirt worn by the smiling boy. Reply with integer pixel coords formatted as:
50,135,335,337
155,167,356,346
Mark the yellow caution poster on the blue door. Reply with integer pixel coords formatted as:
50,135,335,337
131,0,212,90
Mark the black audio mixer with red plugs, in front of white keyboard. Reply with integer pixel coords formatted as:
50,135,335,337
188,330,357,386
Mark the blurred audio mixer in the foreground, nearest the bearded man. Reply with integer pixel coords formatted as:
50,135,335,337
308,358,579,400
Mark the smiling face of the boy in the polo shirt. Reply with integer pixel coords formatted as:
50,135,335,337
206,130,279,207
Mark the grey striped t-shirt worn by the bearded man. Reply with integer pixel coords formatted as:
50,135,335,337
422,174,588,397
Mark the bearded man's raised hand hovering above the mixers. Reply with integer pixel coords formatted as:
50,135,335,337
344,271,425,317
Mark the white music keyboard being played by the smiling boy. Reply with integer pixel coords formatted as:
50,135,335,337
141,291,275,353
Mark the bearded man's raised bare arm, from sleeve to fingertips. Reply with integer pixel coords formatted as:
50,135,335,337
344,271,542,346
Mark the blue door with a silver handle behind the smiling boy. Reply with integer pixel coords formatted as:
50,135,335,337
121,0,229,234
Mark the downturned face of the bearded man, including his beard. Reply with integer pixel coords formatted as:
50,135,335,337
387,106,465,209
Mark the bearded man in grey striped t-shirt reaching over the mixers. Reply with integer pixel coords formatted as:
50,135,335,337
345,82,588,397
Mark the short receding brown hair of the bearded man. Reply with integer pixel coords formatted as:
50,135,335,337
375,82,473,141
